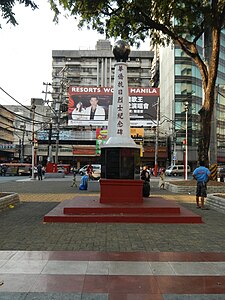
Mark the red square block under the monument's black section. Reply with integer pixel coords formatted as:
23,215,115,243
100,179,143,204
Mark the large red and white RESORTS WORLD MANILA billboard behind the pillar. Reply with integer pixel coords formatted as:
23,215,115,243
68,86,159,126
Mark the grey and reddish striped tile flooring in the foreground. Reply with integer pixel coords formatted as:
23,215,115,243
0,251,225,300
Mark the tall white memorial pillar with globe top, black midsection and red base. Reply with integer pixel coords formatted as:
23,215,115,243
100,40,143,203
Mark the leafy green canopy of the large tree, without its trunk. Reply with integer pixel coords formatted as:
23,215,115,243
51,0,225,45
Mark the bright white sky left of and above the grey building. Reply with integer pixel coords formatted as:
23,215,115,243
0,0,151,105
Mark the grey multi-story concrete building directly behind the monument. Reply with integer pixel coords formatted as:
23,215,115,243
34,40,167,167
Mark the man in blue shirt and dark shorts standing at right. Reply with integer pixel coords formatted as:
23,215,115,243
193,161,211,209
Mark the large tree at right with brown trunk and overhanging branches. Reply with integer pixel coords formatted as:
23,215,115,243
50,0,225,164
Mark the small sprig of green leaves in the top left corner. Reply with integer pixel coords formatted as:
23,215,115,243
0,0,38,28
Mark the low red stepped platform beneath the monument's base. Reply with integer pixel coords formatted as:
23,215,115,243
44,196,203,223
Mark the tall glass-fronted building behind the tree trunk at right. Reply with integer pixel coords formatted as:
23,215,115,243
160,34,225,169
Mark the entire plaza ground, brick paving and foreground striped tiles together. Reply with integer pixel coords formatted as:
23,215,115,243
0,177,225,300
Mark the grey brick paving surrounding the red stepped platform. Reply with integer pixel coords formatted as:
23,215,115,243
0,180,225,252
